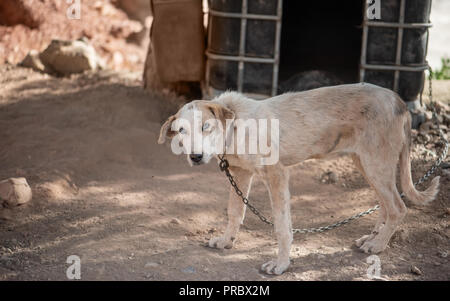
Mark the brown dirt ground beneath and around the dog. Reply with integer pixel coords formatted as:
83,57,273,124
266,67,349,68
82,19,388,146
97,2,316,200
0,65,450,280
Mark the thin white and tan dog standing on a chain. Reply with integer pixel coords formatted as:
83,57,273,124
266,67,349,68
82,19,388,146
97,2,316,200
158,83,439,274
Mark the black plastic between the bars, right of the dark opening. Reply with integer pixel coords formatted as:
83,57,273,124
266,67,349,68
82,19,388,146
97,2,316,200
362,0,431,101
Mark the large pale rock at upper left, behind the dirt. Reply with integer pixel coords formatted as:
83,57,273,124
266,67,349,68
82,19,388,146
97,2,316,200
39,39,104,75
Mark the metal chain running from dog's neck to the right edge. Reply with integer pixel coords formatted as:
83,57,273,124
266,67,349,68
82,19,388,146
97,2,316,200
218,69,449,234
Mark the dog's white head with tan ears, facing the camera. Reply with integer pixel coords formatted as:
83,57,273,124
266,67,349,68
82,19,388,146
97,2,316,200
158,100,235,165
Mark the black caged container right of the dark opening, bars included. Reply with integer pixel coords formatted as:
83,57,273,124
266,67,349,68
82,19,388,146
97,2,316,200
360,0,431,101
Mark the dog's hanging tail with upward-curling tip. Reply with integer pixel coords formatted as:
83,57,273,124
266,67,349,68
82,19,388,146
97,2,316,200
400,112,439,205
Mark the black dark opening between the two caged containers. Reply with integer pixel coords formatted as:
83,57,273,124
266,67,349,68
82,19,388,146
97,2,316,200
278,0,364,89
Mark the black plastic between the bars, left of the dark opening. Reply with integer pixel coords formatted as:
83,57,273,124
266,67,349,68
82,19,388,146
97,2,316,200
207,0,278,95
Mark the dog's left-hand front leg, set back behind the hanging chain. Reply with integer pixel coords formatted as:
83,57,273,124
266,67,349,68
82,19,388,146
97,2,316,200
208,167,253,249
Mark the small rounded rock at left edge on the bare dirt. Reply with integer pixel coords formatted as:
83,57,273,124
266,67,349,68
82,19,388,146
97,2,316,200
0,178,32,206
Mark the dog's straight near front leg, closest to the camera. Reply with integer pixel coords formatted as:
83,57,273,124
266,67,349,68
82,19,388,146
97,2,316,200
261,166,293,275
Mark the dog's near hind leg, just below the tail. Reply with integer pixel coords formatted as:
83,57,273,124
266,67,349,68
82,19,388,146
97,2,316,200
360,153,407,253
